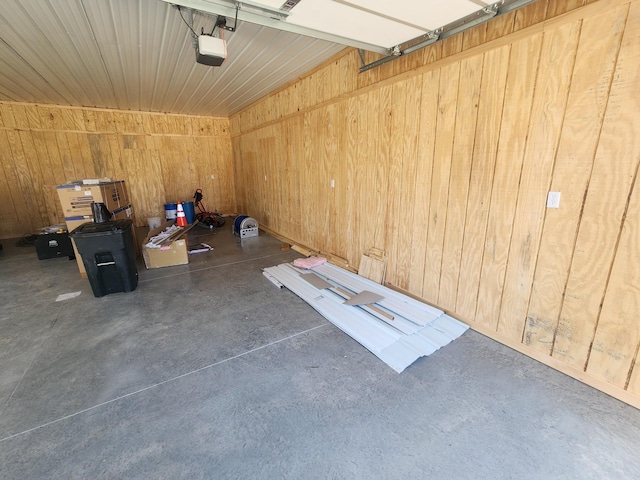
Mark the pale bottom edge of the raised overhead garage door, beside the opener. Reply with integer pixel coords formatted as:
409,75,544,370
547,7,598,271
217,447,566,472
162,0,390,55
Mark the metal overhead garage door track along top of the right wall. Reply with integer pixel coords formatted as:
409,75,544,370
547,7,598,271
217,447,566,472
360,0,537,73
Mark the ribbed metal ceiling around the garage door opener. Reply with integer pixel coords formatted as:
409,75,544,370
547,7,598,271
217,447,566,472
0,0,344,116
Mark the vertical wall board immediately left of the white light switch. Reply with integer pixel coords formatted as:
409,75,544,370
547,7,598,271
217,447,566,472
498,18,579,342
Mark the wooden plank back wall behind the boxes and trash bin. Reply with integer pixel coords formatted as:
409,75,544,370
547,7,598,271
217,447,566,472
0,103,235,238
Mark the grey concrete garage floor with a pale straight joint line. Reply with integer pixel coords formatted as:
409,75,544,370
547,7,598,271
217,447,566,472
0,226,640,480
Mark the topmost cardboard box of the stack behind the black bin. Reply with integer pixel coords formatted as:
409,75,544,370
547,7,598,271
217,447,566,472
56,180,129,217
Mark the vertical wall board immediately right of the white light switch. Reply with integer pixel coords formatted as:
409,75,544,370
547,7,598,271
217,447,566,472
524,6,628,355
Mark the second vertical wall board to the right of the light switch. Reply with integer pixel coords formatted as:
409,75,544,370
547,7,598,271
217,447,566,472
553,3,640,369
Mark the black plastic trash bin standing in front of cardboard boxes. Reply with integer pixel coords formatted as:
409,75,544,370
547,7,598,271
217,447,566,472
69,219,138,297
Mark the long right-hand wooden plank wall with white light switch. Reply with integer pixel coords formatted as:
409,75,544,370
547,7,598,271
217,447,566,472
231,0,640,406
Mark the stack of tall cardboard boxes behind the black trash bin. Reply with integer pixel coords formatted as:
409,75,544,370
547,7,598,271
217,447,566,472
56,180,133,278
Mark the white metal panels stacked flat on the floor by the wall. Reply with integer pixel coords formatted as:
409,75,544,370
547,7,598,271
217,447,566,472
264,263,469,373
